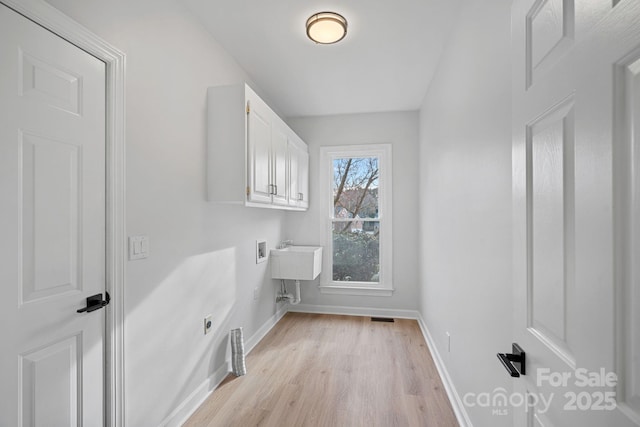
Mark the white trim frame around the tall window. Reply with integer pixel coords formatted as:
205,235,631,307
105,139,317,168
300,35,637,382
319,144,394,296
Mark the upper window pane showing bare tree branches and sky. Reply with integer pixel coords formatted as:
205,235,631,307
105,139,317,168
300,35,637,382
333,157,380,218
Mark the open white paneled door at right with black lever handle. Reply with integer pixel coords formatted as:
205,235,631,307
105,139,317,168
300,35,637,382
505,0,640,427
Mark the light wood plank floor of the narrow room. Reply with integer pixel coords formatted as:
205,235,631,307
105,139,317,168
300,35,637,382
185,313,458,427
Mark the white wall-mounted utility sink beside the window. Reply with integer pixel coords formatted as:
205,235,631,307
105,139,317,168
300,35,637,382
271,246,322,280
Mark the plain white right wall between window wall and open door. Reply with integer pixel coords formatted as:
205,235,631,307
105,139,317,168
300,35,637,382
420,0,512,426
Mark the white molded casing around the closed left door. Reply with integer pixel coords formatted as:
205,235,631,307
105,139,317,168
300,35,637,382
0,0,126,427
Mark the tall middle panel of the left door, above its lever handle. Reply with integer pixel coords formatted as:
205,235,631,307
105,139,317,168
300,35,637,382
18,130,83,305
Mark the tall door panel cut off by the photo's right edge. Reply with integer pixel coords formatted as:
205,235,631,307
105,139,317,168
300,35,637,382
613,48,640,424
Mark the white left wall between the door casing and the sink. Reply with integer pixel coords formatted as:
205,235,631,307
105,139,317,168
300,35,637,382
42,0,285,427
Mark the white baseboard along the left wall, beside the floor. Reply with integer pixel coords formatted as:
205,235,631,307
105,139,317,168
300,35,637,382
160,306,287,427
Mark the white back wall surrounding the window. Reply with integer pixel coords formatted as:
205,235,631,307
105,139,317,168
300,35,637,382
286,112,418,311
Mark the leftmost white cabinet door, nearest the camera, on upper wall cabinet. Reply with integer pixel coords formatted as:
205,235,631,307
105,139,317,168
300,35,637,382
247,100,273,203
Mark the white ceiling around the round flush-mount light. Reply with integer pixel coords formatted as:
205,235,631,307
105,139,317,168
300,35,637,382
182,0,460,117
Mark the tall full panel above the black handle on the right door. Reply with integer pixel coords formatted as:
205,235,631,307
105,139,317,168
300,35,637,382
525,94,576,369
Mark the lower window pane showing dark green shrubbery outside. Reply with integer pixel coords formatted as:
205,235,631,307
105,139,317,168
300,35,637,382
333,221,380,282
